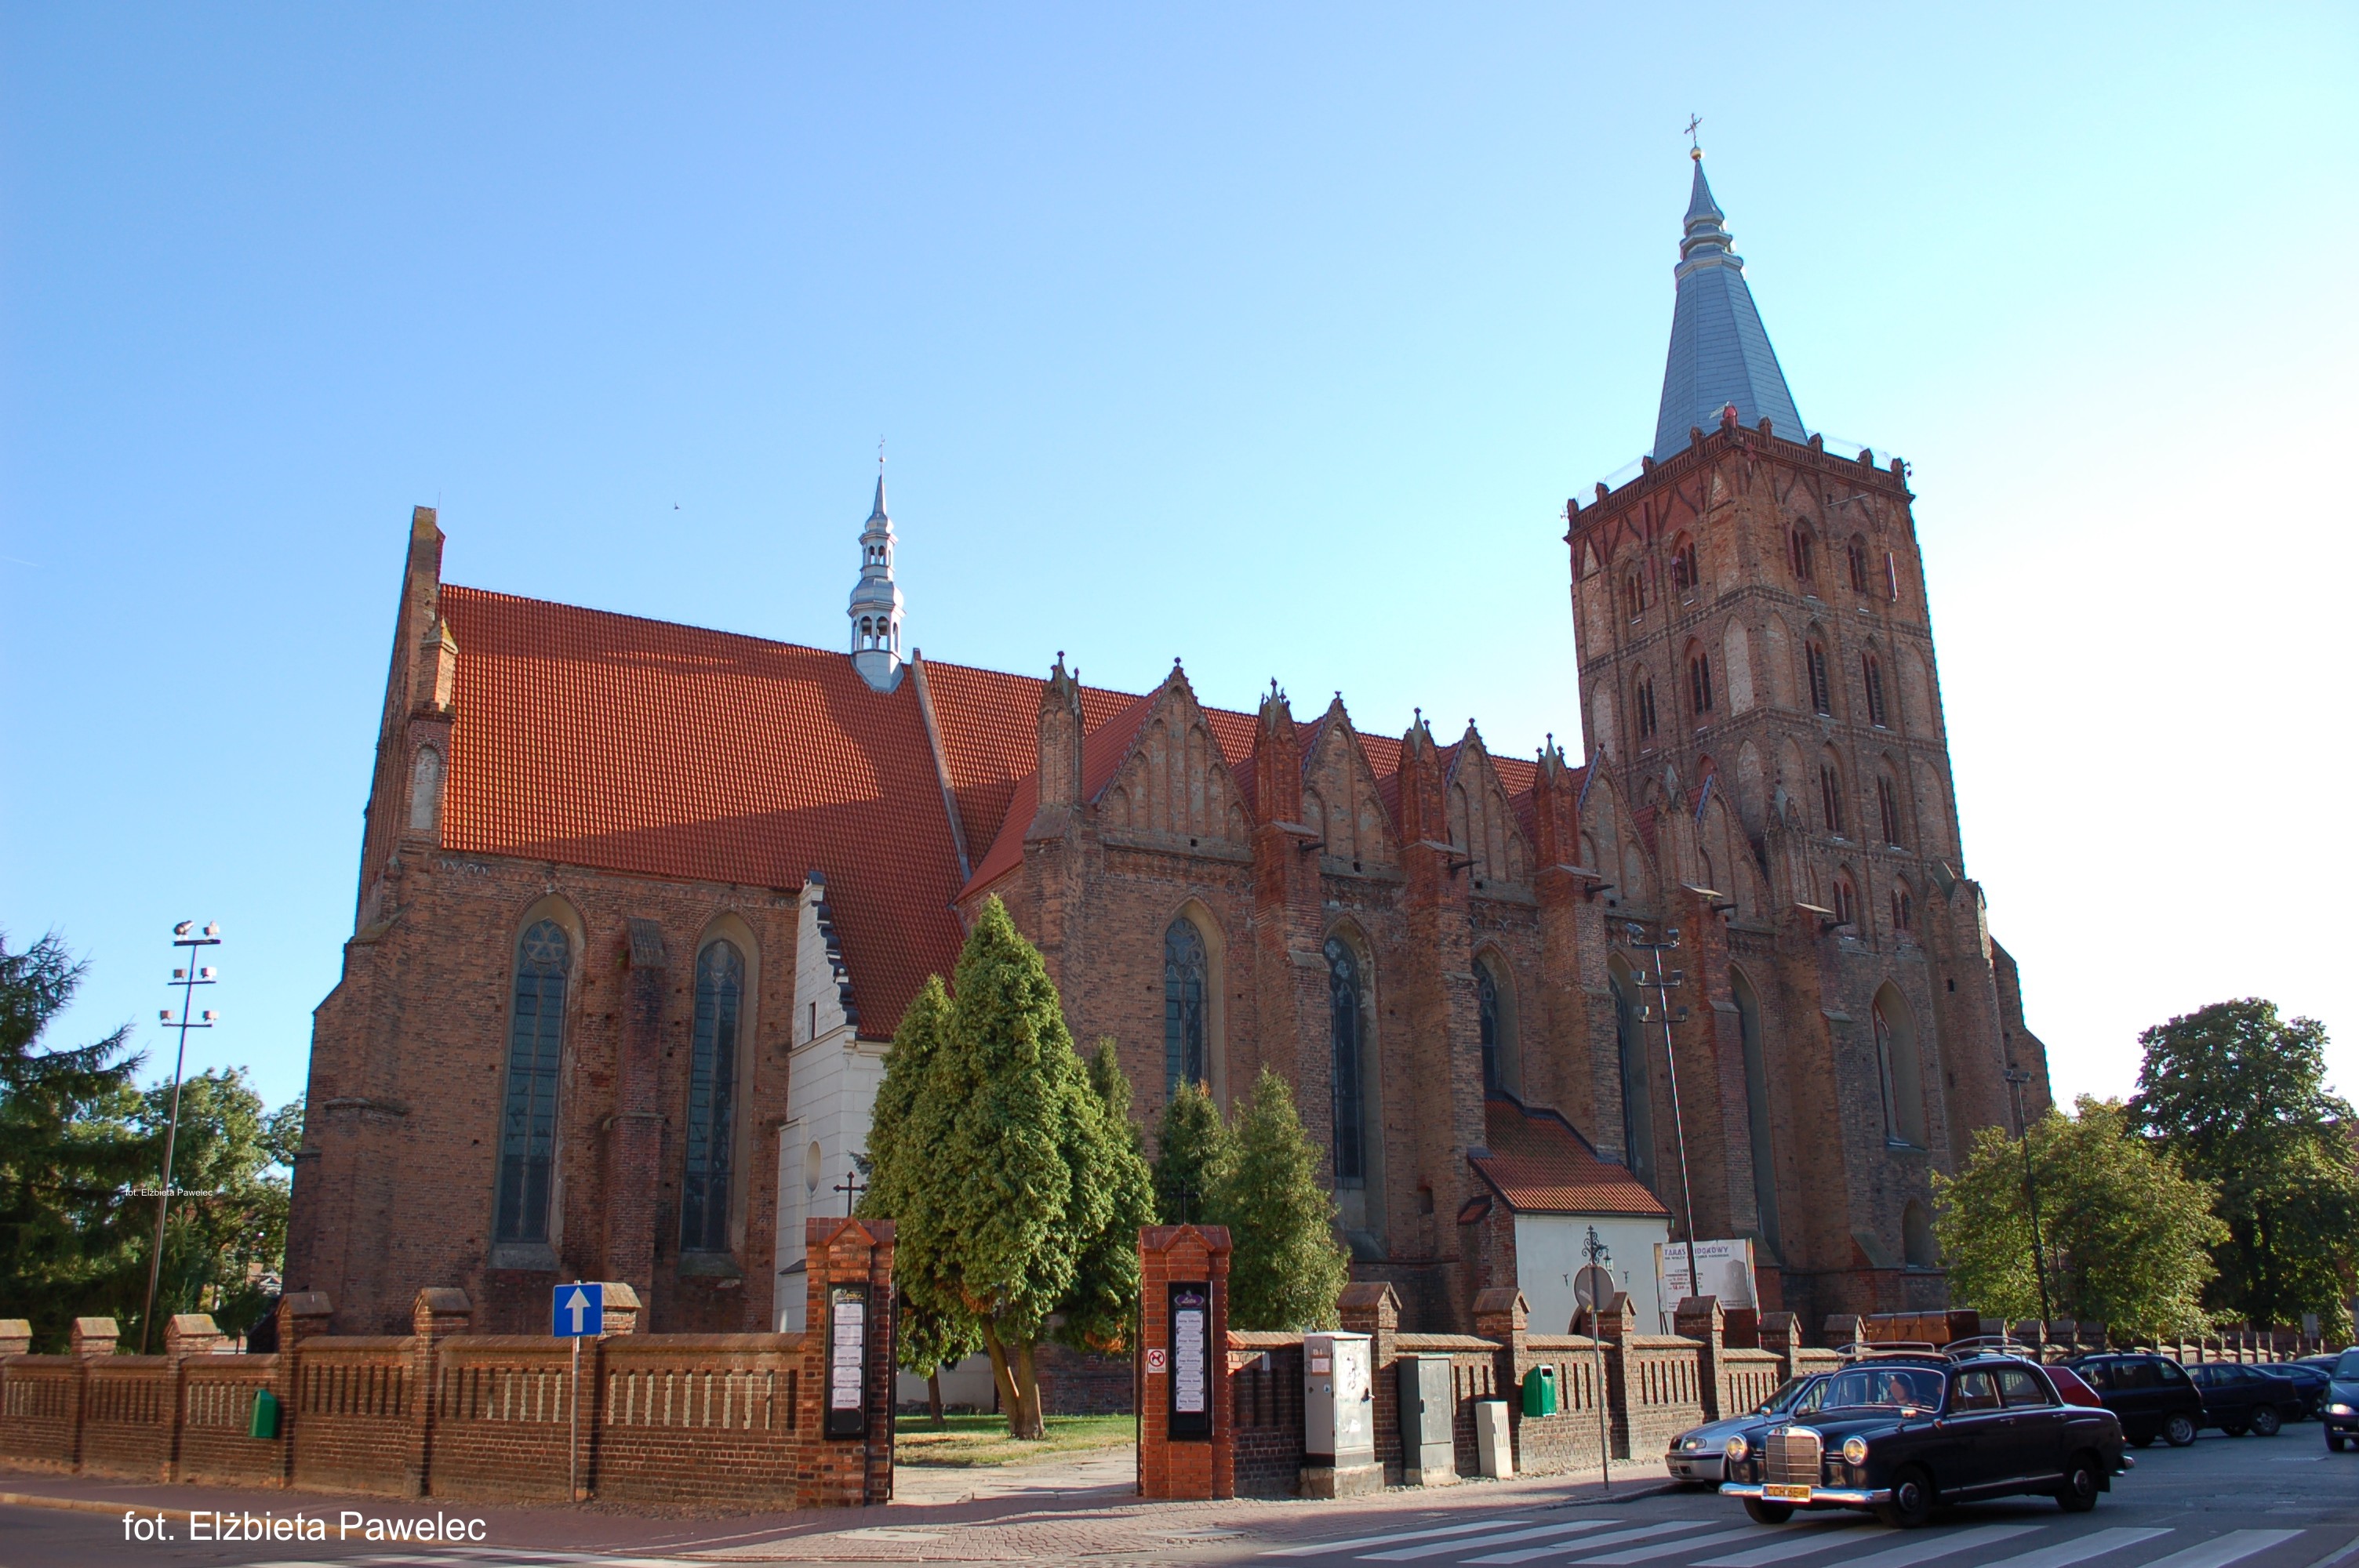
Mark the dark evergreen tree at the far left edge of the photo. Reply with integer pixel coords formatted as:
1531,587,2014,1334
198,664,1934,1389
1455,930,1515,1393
0,934,149,1348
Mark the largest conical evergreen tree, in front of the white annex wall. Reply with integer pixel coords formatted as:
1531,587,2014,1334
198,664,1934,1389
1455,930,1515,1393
863,898,1147,1439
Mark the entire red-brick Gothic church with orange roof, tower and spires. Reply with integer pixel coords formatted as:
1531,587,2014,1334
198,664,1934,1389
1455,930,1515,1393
288,155,2048,1332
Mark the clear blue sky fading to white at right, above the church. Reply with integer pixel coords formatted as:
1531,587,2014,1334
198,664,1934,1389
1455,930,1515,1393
0,2,2359,1117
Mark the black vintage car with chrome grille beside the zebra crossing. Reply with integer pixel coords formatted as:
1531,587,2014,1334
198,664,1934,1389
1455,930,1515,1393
1720,1353,2132,1528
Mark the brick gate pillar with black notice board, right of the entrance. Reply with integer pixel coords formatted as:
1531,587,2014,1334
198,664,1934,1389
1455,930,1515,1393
1140,1226,1236,1502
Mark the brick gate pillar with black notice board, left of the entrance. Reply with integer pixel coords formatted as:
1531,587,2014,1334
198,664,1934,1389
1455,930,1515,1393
795,1219,899,1507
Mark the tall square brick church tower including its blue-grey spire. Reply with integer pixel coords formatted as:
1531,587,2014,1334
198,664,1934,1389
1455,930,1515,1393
1566,151,2045,1311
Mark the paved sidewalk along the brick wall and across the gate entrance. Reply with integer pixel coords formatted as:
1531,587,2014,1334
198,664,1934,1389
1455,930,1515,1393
0,1448,1666,1563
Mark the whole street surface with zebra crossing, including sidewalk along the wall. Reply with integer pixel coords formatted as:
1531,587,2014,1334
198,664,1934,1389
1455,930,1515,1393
0,1422,2359,1568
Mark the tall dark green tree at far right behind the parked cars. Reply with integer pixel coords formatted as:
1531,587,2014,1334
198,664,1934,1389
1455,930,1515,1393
2130,997,2359,1325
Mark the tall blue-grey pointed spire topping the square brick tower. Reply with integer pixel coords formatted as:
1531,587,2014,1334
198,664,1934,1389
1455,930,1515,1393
1654,151,1805,462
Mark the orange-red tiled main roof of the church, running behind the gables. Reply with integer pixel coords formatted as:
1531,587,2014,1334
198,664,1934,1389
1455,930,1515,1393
438,585,1566,1035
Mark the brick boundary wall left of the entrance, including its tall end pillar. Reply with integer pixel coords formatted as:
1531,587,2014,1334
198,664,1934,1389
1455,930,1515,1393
0,1219,892,1507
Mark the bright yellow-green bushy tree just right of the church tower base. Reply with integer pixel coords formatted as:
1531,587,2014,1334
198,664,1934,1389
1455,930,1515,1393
1932,1094,2225,1339
